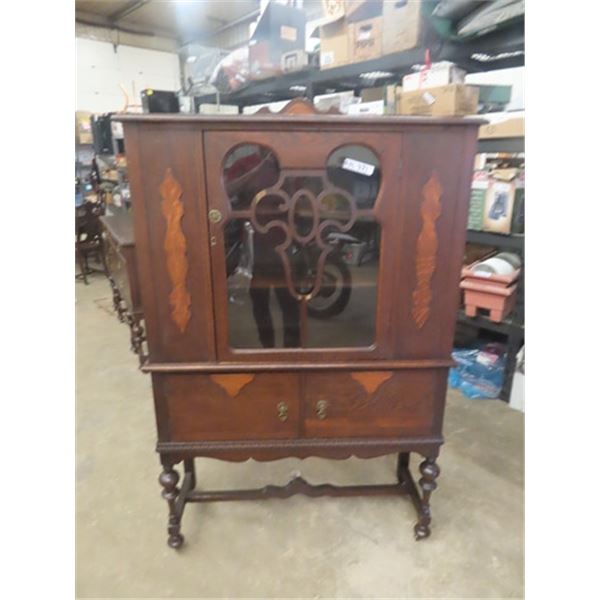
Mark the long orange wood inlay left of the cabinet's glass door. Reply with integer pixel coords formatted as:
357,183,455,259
160,169,191,333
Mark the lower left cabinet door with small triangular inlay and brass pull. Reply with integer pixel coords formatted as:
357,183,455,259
162,373,300,441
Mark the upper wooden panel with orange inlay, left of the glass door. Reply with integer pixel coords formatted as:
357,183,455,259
125,123,215,362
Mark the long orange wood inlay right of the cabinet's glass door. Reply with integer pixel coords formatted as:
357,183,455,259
412,172,442,329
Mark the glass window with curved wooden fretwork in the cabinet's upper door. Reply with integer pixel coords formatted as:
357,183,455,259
207,133,397,356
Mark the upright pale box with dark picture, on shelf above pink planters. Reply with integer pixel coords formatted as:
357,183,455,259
483,169,524,234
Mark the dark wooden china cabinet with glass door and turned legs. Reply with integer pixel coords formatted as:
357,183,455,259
117,101,480,548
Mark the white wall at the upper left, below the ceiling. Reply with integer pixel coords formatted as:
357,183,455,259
76,38,181,113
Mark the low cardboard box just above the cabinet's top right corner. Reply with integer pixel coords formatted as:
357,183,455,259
396,84,479,117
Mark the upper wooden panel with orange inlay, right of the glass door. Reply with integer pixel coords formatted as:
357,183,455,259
394,127,477,358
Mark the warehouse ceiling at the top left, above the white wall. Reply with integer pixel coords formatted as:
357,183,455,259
75,0,260,44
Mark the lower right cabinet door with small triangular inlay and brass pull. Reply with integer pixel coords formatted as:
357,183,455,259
304,369,443,437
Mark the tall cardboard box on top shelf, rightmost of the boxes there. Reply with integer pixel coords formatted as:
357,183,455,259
382,0,424,55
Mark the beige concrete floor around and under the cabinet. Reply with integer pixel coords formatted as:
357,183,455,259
76,275,523,598
